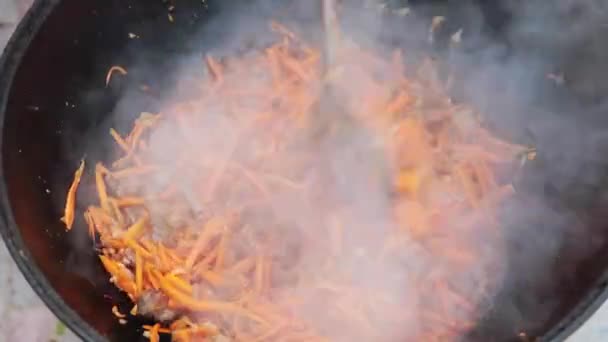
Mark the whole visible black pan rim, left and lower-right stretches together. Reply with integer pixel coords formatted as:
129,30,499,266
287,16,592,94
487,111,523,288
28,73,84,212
0,0,608,341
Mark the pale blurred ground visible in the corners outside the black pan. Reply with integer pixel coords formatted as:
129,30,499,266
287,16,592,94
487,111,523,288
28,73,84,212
0,0,608,342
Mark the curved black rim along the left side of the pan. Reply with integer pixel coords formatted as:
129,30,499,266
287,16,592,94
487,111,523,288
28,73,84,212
0,0,106,341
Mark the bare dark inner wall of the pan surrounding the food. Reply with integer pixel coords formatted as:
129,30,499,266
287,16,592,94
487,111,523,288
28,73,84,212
0,0,608,341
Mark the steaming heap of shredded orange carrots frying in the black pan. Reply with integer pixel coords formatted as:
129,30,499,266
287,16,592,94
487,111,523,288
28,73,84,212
64,23,525,342
